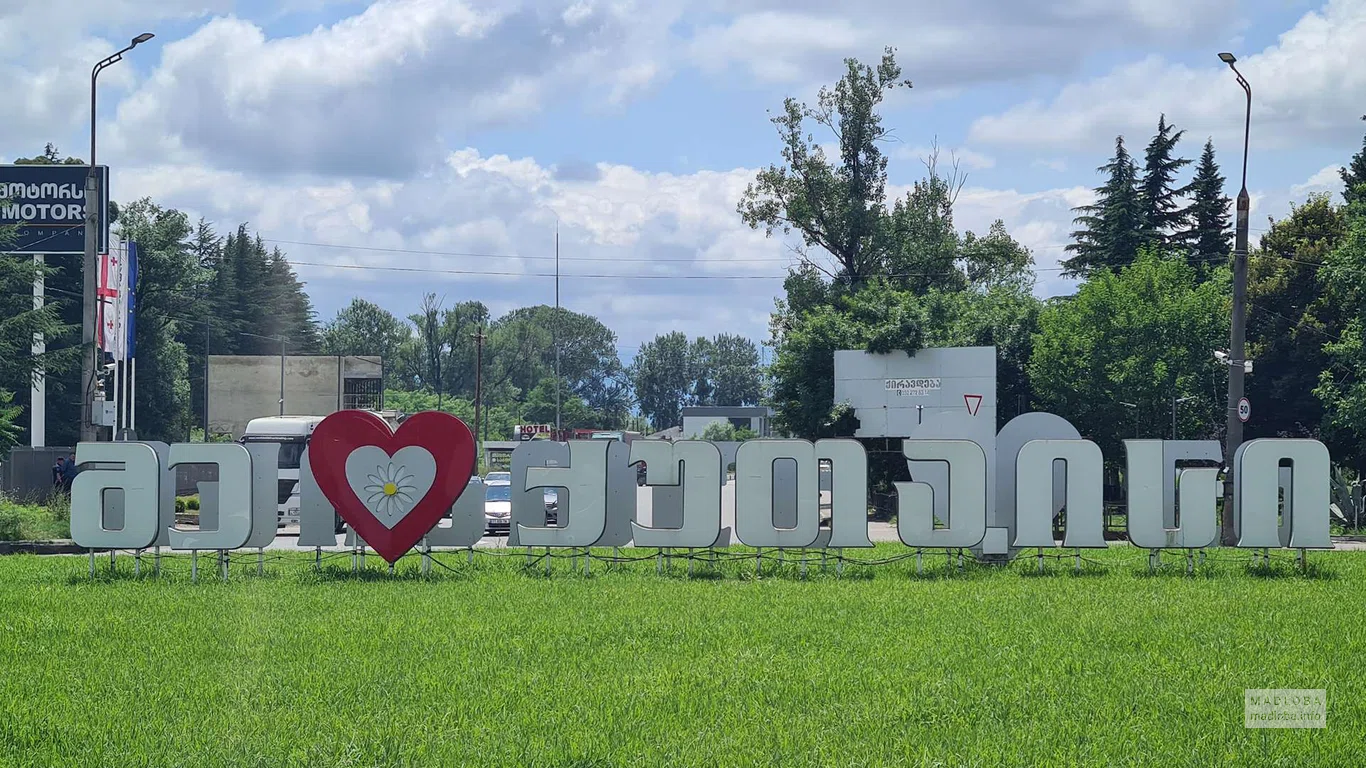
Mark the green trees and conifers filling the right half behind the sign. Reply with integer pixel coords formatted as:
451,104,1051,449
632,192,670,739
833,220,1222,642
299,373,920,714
754,49,1366,473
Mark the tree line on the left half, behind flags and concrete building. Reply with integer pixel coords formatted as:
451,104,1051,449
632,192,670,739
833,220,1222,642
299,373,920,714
0,145,759,448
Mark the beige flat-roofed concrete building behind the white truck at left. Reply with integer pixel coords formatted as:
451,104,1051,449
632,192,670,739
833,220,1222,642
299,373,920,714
209,355,384,439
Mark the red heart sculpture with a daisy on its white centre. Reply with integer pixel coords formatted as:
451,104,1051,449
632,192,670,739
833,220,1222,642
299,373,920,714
309,410,475,563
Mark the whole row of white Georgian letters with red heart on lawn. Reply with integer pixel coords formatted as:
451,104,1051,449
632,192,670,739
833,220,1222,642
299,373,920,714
71,411,1332,563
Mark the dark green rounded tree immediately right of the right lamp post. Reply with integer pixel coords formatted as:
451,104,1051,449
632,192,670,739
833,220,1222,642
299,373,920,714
1244,194,1347,439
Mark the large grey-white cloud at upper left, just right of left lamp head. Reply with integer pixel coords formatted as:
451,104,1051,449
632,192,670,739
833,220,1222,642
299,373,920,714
108,0,669,178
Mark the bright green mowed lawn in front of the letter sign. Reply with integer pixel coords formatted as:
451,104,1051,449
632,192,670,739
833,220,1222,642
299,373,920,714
0,545,1366,767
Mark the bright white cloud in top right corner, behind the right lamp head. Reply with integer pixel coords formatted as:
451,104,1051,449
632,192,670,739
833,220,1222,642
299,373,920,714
968,0,1366,149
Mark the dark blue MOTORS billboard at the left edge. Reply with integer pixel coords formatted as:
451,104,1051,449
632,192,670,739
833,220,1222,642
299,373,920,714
0,165,109,254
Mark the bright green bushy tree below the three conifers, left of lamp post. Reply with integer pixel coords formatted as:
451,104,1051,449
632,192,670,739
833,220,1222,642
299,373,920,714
1027,251,1228,456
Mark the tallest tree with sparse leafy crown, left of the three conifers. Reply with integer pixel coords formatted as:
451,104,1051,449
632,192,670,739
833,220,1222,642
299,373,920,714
736,48,911,286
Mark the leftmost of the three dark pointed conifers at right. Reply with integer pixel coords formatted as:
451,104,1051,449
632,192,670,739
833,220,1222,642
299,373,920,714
1063,137,1145,276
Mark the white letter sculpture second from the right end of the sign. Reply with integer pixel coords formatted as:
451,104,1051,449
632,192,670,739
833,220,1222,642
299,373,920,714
1124,440,1218,549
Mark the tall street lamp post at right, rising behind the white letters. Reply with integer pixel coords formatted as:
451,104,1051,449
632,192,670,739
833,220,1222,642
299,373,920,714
1218,53,1253,545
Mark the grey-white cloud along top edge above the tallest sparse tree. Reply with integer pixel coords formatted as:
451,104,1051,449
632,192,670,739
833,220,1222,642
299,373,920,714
688,0,1235,90
